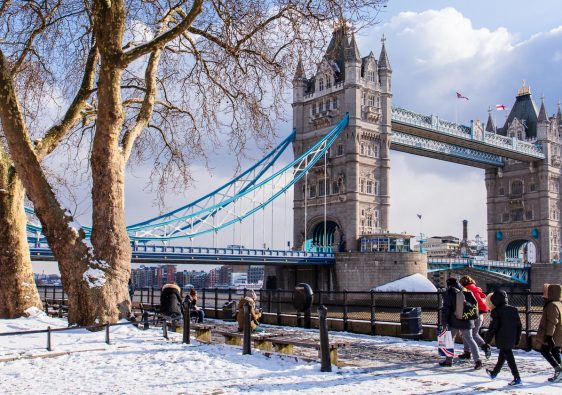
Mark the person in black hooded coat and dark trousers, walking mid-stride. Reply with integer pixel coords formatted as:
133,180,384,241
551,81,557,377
484,291,522,385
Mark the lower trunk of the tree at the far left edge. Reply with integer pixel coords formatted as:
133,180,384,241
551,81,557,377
0,172,43,318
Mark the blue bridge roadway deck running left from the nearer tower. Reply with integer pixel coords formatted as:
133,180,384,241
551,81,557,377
30,246,336,265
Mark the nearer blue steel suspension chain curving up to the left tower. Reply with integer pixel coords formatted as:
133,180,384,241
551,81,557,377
131,114,349,241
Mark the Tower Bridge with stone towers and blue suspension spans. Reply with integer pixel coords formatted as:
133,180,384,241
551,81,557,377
28,27,562,286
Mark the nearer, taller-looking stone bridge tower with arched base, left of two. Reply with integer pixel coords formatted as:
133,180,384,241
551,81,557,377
293,26,392,251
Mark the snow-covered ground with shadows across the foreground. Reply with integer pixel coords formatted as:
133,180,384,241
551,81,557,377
0,314,562,394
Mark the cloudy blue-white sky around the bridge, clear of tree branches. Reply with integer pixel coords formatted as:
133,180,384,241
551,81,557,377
35,0,562,276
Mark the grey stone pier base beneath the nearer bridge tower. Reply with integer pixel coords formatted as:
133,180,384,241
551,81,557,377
334,252,427,291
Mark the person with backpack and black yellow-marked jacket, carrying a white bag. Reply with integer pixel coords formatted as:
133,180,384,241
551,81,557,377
439,277,482,370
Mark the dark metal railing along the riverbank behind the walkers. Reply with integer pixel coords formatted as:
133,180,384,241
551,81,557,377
38,286,544,334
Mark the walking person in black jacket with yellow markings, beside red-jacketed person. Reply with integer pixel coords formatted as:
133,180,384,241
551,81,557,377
439,277,482,370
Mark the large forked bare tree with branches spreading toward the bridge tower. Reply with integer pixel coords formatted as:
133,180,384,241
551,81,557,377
0,0,385,324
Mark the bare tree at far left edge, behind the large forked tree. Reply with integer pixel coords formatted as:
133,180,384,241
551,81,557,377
0,1,97,318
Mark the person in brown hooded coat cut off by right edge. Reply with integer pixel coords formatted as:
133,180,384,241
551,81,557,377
533,284,562,383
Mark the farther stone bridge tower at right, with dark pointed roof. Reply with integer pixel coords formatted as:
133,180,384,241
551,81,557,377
486,83,562,263
